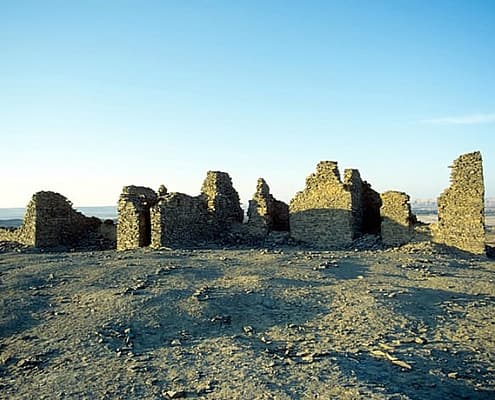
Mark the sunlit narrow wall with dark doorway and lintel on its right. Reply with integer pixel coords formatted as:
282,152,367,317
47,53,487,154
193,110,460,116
117,186,158,250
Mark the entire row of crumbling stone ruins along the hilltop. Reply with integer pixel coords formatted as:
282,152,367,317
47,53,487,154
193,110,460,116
0,152,486,254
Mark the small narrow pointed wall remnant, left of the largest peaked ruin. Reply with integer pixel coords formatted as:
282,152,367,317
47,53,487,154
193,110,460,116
247,178,289,239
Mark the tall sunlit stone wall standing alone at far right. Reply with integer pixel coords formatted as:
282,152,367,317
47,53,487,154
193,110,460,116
431,151,485,254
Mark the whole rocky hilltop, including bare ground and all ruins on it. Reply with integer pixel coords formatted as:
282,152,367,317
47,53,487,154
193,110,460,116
0,152,495,400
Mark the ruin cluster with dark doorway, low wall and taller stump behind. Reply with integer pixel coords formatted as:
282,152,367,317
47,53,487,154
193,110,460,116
117,171,244,250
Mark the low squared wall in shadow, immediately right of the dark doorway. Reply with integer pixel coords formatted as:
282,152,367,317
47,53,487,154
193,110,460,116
151,193,207,248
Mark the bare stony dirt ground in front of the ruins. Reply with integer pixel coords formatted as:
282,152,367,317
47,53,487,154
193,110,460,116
0,239,495,399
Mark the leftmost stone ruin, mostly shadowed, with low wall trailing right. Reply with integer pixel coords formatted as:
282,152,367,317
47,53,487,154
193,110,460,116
0,192,115,249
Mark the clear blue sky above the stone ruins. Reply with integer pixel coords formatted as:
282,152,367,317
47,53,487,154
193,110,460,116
0,0,495,207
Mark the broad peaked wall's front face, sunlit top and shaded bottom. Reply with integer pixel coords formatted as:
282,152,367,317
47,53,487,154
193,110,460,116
289,161,355,248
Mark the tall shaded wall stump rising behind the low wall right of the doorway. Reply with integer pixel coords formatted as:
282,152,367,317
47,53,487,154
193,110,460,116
201,171,244,234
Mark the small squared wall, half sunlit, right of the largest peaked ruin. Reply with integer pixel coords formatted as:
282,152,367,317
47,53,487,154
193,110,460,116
380,191,415,246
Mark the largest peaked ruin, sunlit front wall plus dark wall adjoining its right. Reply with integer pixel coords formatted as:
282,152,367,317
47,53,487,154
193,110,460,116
289,161,381,248
